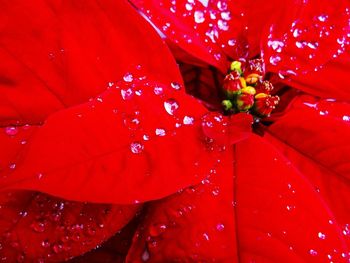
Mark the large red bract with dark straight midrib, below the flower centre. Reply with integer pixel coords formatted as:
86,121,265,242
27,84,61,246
127,137,348,263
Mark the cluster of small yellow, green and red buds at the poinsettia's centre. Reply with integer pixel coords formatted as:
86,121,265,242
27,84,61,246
221,59,280,118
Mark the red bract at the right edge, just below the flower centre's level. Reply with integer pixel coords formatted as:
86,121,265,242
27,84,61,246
269,96,350,183
